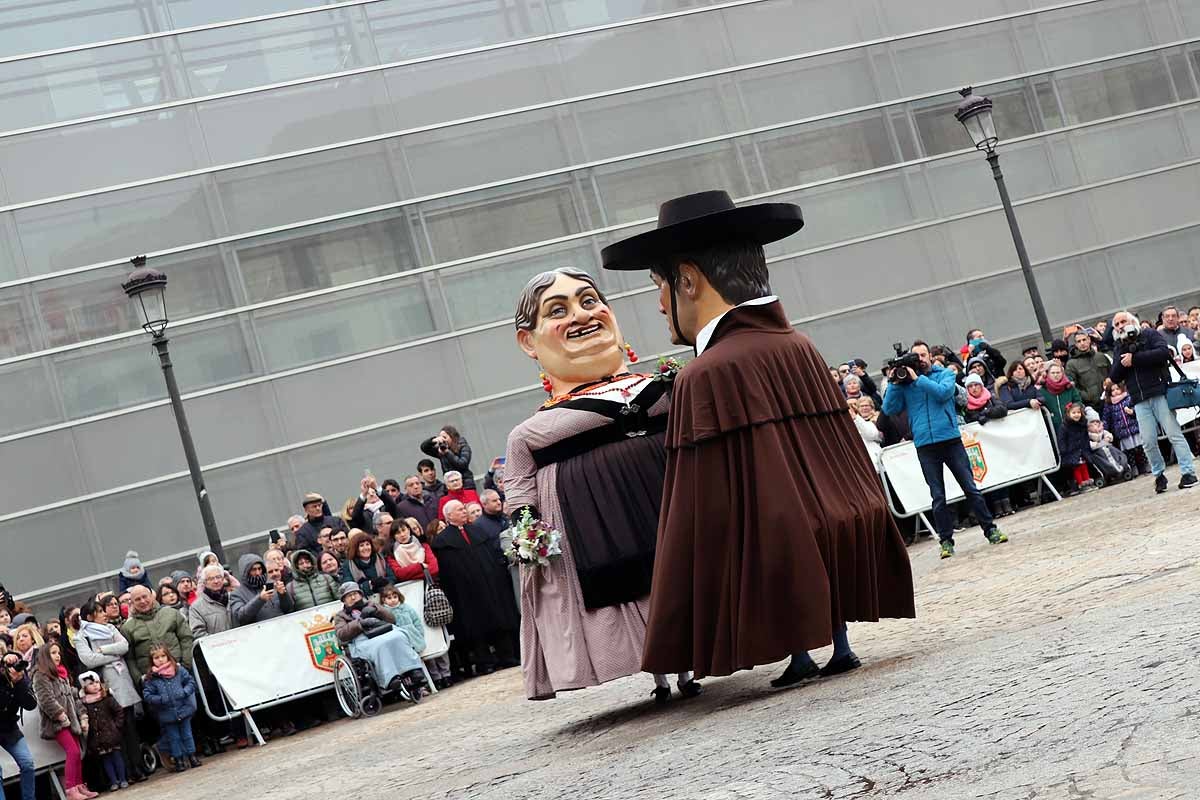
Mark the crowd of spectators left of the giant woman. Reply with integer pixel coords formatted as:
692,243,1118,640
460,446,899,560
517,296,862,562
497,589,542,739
0,426,518,800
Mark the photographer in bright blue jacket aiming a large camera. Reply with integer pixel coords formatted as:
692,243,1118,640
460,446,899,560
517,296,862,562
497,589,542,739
883,341,1008,559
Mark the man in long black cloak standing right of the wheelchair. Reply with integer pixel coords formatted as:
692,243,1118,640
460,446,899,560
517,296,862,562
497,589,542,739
433,500,521,675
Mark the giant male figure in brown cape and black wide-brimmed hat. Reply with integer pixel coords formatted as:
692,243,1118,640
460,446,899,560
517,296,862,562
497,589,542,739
602,192,916,686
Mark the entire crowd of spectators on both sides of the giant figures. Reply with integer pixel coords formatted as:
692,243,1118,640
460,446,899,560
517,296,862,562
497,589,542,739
0,306,1200,800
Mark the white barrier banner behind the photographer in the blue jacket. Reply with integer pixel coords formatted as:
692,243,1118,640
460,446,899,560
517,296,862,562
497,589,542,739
881,409,1058,515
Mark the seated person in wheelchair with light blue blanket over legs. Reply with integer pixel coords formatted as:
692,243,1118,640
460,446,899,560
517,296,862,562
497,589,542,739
334,581,425,700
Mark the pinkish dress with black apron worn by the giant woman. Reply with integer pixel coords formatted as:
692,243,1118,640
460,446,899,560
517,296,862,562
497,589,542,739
505,375,670,699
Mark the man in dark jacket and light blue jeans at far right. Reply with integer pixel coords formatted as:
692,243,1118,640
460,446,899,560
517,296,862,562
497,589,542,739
1109,311,1196,494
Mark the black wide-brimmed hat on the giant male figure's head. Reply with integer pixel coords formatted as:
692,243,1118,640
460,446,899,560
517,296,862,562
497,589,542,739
600,191,804,270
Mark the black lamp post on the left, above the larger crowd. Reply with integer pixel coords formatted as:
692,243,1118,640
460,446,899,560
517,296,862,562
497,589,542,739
121,255,226,564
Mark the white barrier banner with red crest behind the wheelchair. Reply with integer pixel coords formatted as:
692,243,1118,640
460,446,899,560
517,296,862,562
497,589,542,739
197,581,449,709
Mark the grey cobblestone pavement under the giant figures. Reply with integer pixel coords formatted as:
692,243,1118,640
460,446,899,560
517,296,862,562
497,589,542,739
122,470,1200,800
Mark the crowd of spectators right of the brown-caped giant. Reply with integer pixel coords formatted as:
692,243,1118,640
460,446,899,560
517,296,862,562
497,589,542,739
829,306,1200,544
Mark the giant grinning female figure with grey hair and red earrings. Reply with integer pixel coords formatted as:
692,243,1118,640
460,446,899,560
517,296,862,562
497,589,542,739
505,269,701,703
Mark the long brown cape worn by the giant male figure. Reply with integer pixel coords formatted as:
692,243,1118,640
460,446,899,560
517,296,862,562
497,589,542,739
642,302,916,676
